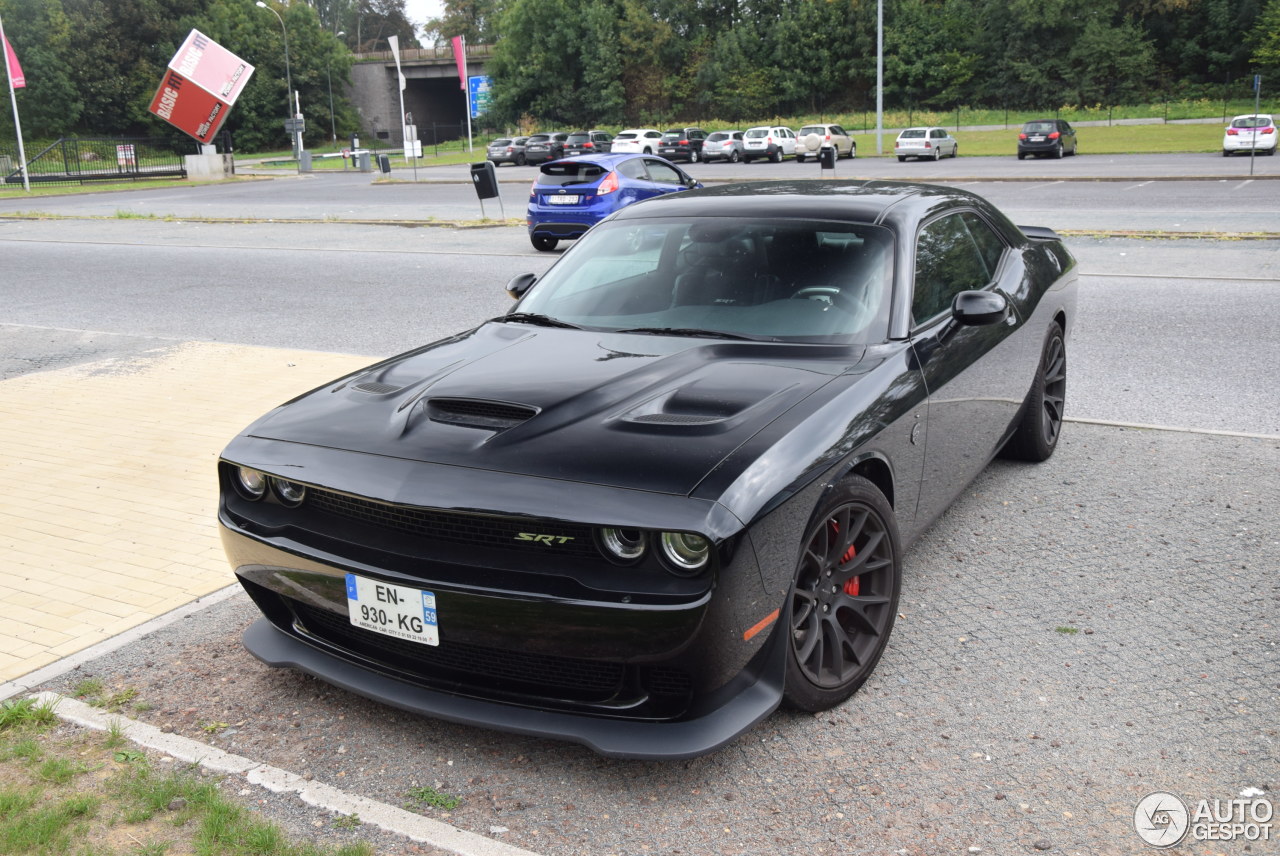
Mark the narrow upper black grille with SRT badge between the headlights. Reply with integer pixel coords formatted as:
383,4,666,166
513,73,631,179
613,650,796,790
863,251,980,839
307,487,600,559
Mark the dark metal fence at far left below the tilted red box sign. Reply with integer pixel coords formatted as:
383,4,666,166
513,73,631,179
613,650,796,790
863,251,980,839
0,137,200,186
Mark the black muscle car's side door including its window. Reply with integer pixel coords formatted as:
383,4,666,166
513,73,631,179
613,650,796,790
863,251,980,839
911,210,1028,521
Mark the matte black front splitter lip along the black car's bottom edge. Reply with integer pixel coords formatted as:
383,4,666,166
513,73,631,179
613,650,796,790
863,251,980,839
242,618,786,761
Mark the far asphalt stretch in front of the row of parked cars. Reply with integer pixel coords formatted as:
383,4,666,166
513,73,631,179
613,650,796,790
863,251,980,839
0,155,1280,233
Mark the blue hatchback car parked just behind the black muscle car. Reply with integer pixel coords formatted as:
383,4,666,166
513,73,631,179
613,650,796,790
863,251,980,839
526,154,701,251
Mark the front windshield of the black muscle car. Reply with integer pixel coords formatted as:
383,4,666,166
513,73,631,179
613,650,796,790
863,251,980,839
517,218,893,344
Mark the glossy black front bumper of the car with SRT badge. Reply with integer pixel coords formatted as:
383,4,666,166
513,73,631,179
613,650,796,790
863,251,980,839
219,440,785,759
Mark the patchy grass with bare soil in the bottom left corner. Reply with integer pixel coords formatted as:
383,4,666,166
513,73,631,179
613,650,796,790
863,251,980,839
0,683,374,856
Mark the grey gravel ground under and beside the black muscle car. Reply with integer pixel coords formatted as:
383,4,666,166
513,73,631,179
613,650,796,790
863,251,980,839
32,424,1280,856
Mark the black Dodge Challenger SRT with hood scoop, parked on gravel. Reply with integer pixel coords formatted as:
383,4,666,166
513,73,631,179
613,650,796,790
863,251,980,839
219,180,1076,759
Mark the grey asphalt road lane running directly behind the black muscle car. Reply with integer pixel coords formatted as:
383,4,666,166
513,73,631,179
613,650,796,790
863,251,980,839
0,220,1280,435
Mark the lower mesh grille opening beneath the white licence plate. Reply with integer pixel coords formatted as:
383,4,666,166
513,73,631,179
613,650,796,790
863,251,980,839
289,600,626,701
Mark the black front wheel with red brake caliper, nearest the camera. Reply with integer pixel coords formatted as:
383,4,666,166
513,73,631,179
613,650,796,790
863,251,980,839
782,476,902,711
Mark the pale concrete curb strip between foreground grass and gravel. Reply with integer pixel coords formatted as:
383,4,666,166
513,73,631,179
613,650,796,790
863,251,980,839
35,692,539,856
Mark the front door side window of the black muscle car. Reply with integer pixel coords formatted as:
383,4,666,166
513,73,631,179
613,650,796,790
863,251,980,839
911,212,1004,324
